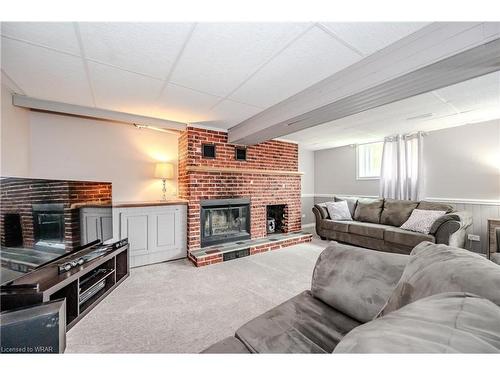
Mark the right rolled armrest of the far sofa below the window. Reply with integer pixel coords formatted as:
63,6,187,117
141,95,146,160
430,211,472,248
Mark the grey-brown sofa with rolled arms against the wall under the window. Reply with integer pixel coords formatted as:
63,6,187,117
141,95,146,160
313,197,472,254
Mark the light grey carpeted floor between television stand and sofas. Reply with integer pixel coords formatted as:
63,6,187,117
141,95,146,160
66,238,328,353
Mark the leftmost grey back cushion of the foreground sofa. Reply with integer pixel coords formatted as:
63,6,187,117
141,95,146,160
311,243,409,322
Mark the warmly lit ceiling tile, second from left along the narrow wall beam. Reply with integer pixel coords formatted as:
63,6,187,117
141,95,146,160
89,62,163,116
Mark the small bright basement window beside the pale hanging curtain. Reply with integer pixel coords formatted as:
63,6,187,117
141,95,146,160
356,142,384,180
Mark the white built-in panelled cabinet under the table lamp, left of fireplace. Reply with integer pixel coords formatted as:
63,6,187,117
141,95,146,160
113,204,187,267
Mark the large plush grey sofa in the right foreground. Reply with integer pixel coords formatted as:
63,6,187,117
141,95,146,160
204,242,500,353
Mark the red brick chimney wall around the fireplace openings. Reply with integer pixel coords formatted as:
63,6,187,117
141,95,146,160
178,127,301,250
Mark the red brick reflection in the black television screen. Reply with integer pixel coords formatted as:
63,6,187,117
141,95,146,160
0,178,112,251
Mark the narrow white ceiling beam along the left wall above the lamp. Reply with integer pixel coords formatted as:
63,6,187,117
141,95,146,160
12,94,186,131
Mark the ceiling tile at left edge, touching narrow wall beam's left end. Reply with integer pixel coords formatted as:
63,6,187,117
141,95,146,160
2,38,93,106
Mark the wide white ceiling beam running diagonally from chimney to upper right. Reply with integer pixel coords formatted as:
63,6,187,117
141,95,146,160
228,22,500,145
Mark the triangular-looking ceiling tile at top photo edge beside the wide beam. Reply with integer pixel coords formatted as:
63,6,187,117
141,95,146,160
324,22,428,55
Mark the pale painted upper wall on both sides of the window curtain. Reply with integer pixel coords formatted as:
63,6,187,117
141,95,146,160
315,120,500,201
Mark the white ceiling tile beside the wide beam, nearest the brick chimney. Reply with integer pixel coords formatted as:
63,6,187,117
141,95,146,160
231,27,361,107
